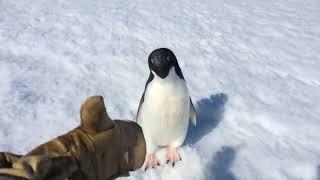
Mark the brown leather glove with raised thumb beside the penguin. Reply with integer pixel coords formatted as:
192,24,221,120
0,96,146,180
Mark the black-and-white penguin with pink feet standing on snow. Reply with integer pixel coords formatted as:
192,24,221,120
136,48,196,170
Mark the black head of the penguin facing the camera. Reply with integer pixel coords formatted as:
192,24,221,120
148,48,183,79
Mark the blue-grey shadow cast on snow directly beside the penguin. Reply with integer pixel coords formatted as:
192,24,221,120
184,93,228,145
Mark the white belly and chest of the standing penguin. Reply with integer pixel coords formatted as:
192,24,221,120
138,73,190,146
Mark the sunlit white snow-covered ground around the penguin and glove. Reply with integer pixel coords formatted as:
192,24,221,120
0,0,320,180
